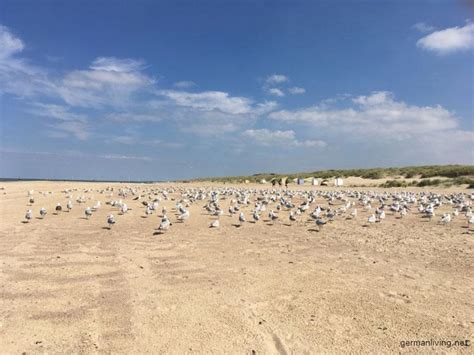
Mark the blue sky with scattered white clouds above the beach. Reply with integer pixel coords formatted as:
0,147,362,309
0,0,474,180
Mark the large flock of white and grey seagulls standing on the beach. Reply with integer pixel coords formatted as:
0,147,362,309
20,186,474,234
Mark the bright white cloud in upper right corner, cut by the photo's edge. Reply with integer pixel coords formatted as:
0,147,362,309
417,23,474,54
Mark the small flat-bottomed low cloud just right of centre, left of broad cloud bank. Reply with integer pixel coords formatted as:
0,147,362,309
242,128,326,148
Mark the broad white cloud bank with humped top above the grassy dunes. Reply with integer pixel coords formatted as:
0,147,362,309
268,91,458,138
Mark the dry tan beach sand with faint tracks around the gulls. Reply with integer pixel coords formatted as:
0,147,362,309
0,182,474,354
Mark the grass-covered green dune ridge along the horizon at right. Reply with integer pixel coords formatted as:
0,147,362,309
190,165,474,187
